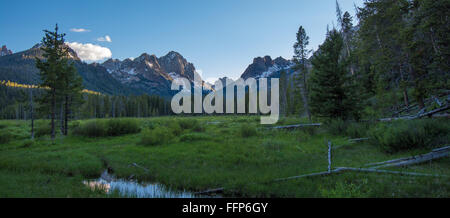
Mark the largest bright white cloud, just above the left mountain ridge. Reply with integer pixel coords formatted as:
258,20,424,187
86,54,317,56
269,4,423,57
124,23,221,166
67,42,112,61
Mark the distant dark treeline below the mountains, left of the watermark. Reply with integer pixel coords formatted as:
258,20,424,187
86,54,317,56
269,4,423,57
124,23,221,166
0,84,172,123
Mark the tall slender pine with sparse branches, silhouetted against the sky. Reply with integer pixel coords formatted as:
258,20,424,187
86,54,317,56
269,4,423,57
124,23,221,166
294,26,311,120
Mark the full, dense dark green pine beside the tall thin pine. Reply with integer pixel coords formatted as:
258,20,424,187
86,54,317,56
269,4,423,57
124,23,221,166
309,29,359,120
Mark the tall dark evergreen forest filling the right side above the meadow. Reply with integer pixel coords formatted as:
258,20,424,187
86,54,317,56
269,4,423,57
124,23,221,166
281,0,450,119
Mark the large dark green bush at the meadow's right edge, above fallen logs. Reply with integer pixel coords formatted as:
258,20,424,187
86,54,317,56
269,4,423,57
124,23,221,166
369,119,450,153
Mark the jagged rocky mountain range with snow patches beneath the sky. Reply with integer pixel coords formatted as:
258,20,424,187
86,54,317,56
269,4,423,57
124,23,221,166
0,44,293,97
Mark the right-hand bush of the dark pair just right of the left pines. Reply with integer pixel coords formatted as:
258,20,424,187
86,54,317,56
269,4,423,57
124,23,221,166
106,119,141,136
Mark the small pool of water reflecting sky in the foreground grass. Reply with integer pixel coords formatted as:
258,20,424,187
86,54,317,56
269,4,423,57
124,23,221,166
83,173,215,198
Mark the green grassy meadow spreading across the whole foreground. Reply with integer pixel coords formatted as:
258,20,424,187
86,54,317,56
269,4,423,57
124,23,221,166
0,116,450,197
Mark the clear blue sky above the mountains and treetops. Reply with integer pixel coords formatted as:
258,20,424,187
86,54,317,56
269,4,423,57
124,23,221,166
0,0,363,81
